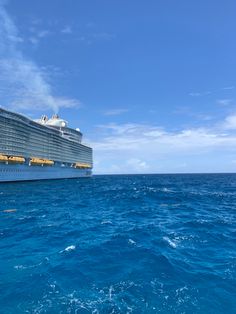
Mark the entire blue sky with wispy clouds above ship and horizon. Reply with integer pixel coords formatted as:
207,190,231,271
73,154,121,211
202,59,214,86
0,0,236,173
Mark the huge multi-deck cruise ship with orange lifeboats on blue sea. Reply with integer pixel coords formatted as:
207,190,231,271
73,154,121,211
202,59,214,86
0,108,93,182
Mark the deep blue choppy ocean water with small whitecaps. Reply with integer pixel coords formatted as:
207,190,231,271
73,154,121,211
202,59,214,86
0,174,236,314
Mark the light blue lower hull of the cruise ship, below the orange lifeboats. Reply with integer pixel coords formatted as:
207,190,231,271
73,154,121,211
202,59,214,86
0,163,92,182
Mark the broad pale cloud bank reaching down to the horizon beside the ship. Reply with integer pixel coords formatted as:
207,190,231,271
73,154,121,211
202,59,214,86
90,120,236,173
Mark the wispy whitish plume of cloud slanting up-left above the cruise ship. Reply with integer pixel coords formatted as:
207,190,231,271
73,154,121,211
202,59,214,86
0,3,80,112
